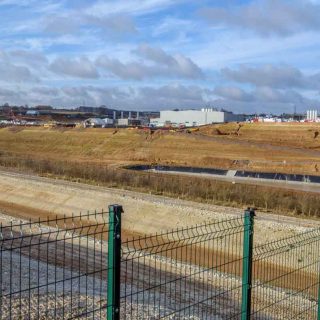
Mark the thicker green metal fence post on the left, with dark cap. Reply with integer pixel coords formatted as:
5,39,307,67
107,204,123,320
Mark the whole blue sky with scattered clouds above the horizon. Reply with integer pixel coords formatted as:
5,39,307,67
0,0,320,114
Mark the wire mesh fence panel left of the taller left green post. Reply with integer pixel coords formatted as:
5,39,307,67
0,212,108,319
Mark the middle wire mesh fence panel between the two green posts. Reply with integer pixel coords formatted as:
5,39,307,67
121,217,244,319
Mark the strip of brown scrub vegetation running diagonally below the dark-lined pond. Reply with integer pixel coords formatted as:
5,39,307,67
0,151,320,217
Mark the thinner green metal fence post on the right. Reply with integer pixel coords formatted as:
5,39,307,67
241,208,255,320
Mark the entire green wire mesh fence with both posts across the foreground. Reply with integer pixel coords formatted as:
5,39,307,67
0,205,320,320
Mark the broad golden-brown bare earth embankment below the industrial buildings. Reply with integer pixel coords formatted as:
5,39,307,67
0,123,320,175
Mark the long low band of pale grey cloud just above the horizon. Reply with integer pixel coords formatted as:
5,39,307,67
0,83,318,113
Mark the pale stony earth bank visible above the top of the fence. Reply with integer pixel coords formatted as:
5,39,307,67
0,171,320,243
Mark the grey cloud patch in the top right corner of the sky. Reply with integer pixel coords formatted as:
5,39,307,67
201,0,320,36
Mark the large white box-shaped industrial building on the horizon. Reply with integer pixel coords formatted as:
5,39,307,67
150,108,244,127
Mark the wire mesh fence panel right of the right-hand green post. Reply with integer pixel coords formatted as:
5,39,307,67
252,229,320,320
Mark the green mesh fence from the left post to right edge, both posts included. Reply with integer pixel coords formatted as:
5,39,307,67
108,205,320,320
